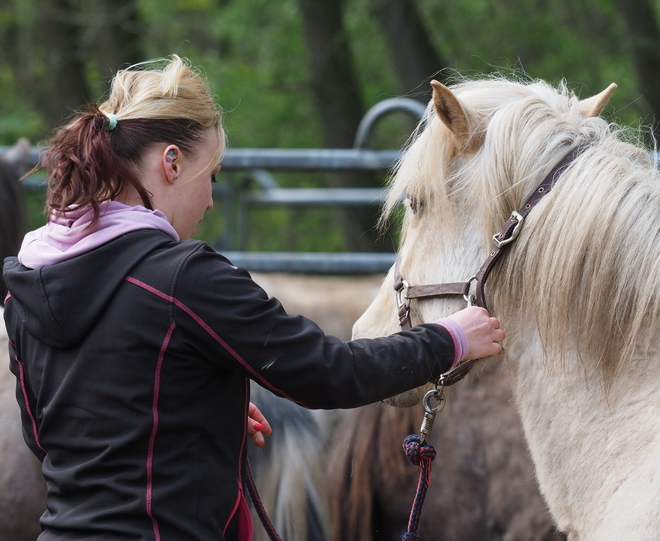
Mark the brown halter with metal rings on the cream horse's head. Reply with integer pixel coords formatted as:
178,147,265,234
394,143,589,386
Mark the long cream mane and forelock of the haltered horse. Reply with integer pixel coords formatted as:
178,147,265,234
383,79,660,381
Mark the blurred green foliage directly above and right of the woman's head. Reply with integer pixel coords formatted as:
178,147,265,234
142,0,322,148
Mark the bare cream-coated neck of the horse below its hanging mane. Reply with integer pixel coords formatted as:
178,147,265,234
504,313,660,540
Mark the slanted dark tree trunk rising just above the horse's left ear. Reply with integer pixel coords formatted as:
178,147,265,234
370,0,448,98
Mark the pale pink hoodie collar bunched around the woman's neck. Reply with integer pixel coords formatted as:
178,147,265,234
18,201,179,269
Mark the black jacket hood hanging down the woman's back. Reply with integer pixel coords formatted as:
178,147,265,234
3,229,173,349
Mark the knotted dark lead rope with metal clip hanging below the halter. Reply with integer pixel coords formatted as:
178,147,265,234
401,382,445,541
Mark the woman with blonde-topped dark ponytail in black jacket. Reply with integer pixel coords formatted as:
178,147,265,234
4,56,504,541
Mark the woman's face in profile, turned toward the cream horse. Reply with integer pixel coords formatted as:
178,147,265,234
168,128,220,240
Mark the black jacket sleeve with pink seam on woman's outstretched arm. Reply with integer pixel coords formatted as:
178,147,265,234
175,245,454,408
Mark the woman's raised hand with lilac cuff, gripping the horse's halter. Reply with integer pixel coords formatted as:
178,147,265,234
449,306,504,359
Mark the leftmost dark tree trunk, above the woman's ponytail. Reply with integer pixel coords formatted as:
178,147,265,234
35,0,90,126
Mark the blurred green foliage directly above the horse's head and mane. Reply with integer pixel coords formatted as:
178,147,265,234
419,0,642,126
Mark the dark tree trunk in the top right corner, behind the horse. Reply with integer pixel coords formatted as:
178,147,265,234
617,0,660,137
